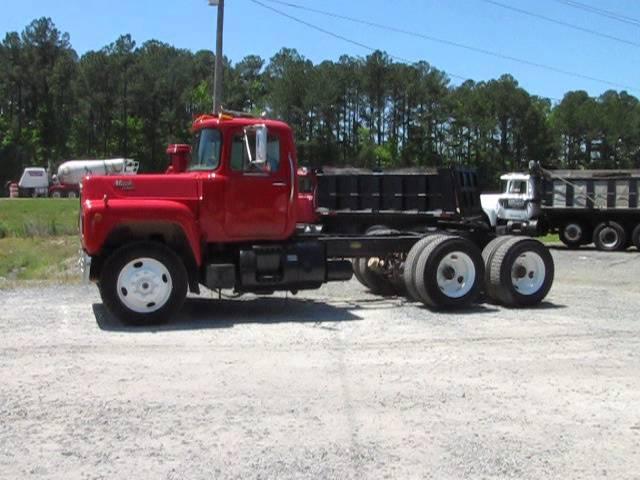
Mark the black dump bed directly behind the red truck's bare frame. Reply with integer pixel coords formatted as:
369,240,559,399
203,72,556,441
317,168,482,231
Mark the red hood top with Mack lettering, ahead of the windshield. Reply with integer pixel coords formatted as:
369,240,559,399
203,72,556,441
82,174,199,201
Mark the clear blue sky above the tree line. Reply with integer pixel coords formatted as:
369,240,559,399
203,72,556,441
0,0,640,98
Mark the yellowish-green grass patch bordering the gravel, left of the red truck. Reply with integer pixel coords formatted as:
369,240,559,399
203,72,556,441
0,235,80,287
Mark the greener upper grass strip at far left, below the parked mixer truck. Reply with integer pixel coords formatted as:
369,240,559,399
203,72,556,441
0,198,80,239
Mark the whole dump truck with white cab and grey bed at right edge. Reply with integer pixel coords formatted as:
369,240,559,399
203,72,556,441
481,162,640,251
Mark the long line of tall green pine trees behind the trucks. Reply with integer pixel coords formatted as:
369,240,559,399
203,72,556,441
0,18,640,189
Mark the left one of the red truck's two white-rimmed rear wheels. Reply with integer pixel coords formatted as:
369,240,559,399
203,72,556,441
415,236,484,309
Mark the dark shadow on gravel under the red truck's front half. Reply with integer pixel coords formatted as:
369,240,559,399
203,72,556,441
92,298,362,332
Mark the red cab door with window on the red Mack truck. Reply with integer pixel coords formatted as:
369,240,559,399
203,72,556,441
225,129,293,240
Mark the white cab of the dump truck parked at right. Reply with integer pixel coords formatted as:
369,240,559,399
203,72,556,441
481,173,540,233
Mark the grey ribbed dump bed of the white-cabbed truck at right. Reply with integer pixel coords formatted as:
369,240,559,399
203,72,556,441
542,170,640,210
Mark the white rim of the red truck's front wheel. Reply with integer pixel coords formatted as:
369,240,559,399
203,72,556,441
117,257,173,313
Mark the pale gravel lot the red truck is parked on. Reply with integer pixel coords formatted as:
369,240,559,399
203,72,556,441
0,249,640,479
